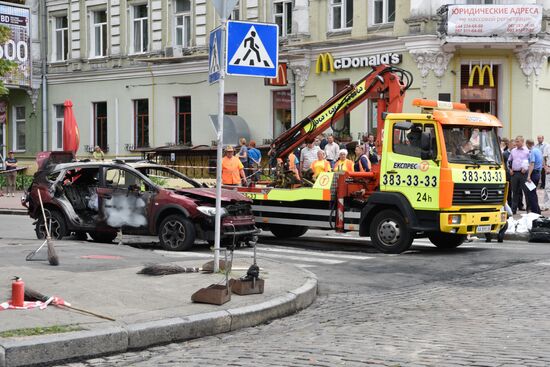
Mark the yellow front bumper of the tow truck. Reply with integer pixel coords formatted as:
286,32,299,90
439,211,507,234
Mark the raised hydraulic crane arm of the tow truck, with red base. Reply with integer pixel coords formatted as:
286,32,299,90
273,65,412,158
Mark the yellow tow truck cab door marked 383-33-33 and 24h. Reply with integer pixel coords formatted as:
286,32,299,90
380,121,440,210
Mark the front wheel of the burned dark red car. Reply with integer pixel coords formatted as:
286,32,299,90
159,214,195,251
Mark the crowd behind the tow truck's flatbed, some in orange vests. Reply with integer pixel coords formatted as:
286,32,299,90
222,134,379,185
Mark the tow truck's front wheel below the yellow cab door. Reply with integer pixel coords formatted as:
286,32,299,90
370,209,414,254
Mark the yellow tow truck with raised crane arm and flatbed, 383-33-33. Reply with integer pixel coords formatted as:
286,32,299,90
237,65,508,253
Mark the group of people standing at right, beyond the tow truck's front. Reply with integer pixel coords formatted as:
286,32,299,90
501,135,550,214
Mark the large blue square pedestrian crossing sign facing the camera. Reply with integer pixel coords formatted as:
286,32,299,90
226,21,279,78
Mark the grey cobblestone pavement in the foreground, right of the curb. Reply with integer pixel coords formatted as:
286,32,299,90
57,253,550,367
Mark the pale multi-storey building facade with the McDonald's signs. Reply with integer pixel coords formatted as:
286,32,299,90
6,0,550,162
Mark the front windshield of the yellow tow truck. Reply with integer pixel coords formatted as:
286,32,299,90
443,126,502,165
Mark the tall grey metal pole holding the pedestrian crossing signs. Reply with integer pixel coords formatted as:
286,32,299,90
214,8,226,273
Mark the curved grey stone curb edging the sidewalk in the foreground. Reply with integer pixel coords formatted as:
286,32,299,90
0,269,318,367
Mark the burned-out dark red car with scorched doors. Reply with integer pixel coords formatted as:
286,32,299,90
22,155,259,251
